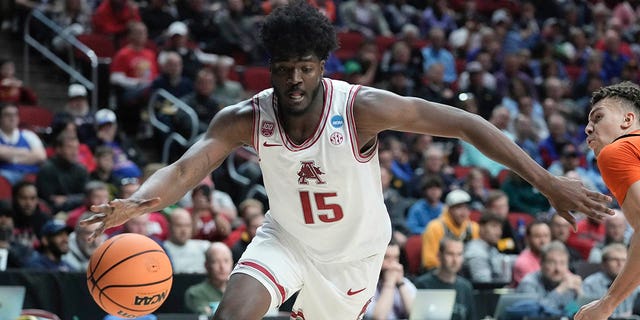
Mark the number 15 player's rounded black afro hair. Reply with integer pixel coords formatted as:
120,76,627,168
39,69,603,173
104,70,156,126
260,0,338,60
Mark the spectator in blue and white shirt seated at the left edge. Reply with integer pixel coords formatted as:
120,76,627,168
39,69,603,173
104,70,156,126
0,102,47,185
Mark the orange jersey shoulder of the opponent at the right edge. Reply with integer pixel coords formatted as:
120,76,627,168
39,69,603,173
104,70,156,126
598,136,640,206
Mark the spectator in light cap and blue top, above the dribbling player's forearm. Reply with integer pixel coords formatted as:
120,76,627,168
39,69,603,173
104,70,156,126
95,109,142,179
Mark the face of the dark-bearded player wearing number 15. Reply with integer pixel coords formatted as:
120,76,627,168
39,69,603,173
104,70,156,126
271,54,325,115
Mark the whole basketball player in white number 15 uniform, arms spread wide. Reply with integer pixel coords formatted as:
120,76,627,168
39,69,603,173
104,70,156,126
83,0,613,320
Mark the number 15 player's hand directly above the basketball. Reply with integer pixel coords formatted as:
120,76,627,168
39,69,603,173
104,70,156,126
79,198,160,241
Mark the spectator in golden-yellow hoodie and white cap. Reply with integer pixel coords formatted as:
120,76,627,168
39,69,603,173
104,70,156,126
422,189,479,270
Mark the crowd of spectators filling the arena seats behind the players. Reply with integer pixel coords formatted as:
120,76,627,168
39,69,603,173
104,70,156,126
0,0,640,319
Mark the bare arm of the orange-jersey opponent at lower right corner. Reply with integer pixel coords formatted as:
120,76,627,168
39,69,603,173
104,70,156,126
574,182,640,320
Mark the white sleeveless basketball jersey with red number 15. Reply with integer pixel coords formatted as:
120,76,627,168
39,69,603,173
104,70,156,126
253,79,391,262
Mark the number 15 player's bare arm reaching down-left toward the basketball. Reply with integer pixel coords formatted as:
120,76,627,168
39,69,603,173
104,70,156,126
80,102,253,238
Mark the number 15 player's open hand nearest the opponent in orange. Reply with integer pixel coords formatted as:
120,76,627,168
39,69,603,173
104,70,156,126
545,176,614,230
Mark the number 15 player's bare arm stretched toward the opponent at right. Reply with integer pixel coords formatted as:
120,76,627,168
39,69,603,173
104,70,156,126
354,87,613,228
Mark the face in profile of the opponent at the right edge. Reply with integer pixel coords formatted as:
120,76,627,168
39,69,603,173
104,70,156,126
584,99,625,156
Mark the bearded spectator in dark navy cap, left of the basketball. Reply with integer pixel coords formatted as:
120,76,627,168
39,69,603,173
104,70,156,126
25,219,73,272
